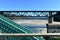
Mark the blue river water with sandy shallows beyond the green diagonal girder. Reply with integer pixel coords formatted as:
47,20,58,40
13,19,48,33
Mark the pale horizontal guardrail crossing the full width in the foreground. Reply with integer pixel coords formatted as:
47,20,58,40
0,33,60,40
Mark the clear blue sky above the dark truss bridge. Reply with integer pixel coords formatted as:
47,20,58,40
0,0,60,10
